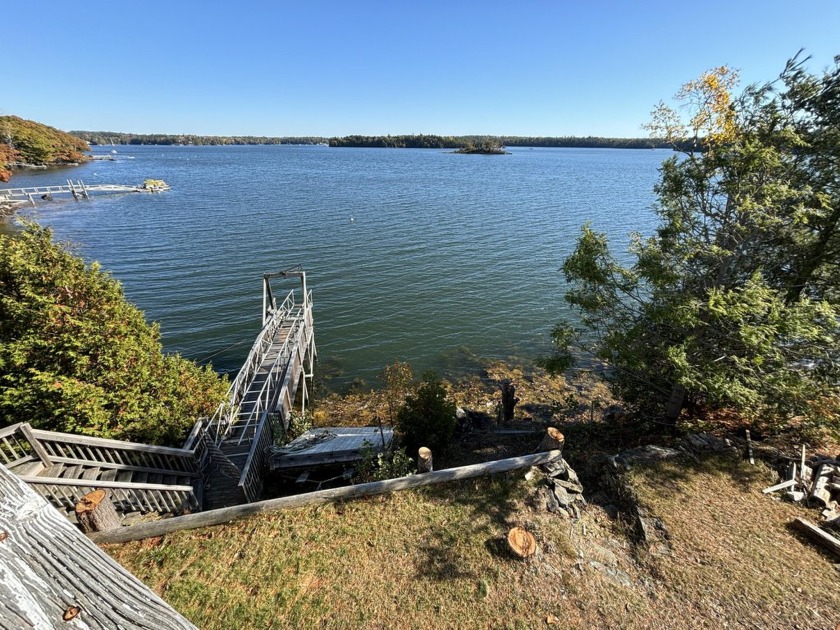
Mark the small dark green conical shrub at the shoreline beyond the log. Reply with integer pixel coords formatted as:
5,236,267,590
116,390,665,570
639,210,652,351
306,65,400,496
396,372,457,453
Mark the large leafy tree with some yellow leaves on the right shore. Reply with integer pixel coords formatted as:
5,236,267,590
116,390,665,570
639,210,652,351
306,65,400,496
555,58,840,430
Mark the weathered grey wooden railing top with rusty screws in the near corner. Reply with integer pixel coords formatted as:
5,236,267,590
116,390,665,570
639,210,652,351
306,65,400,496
0,466,195,630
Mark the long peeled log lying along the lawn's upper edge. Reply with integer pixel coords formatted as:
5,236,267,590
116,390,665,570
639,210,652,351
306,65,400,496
88,451,562,544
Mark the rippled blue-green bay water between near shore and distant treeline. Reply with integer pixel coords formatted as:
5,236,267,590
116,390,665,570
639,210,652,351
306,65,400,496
4,146,669,386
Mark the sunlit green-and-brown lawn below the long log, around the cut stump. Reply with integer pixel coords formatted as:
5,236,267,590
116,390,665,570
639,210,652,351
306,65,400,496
106,458,840,629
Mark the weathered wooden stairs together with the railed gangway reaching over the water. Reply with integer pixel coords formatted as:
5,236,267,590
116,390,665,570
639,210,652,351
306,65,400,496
0,271,315,515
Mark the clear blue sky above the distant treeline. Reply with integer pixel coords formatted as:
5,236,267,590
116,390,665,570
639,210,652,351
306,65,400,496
6,0,840,137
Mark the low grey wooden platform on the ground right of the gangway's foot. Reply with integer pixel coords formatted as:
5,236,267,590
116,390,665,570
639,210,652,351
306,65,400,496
268,427,394,471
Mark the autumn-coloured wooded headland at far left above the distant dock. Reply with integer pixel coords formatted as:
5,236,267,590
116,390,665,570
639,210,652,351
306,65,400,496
0,116,90,182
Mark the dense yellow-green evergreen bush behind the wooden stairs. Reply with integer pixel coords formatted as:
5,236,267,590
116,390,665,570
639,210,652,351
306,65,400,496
0,224,227,445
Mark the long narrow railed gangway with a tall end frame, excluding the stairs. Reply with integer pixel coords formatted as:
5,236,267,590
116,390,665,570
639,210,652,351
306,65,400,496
184,269,316,509
